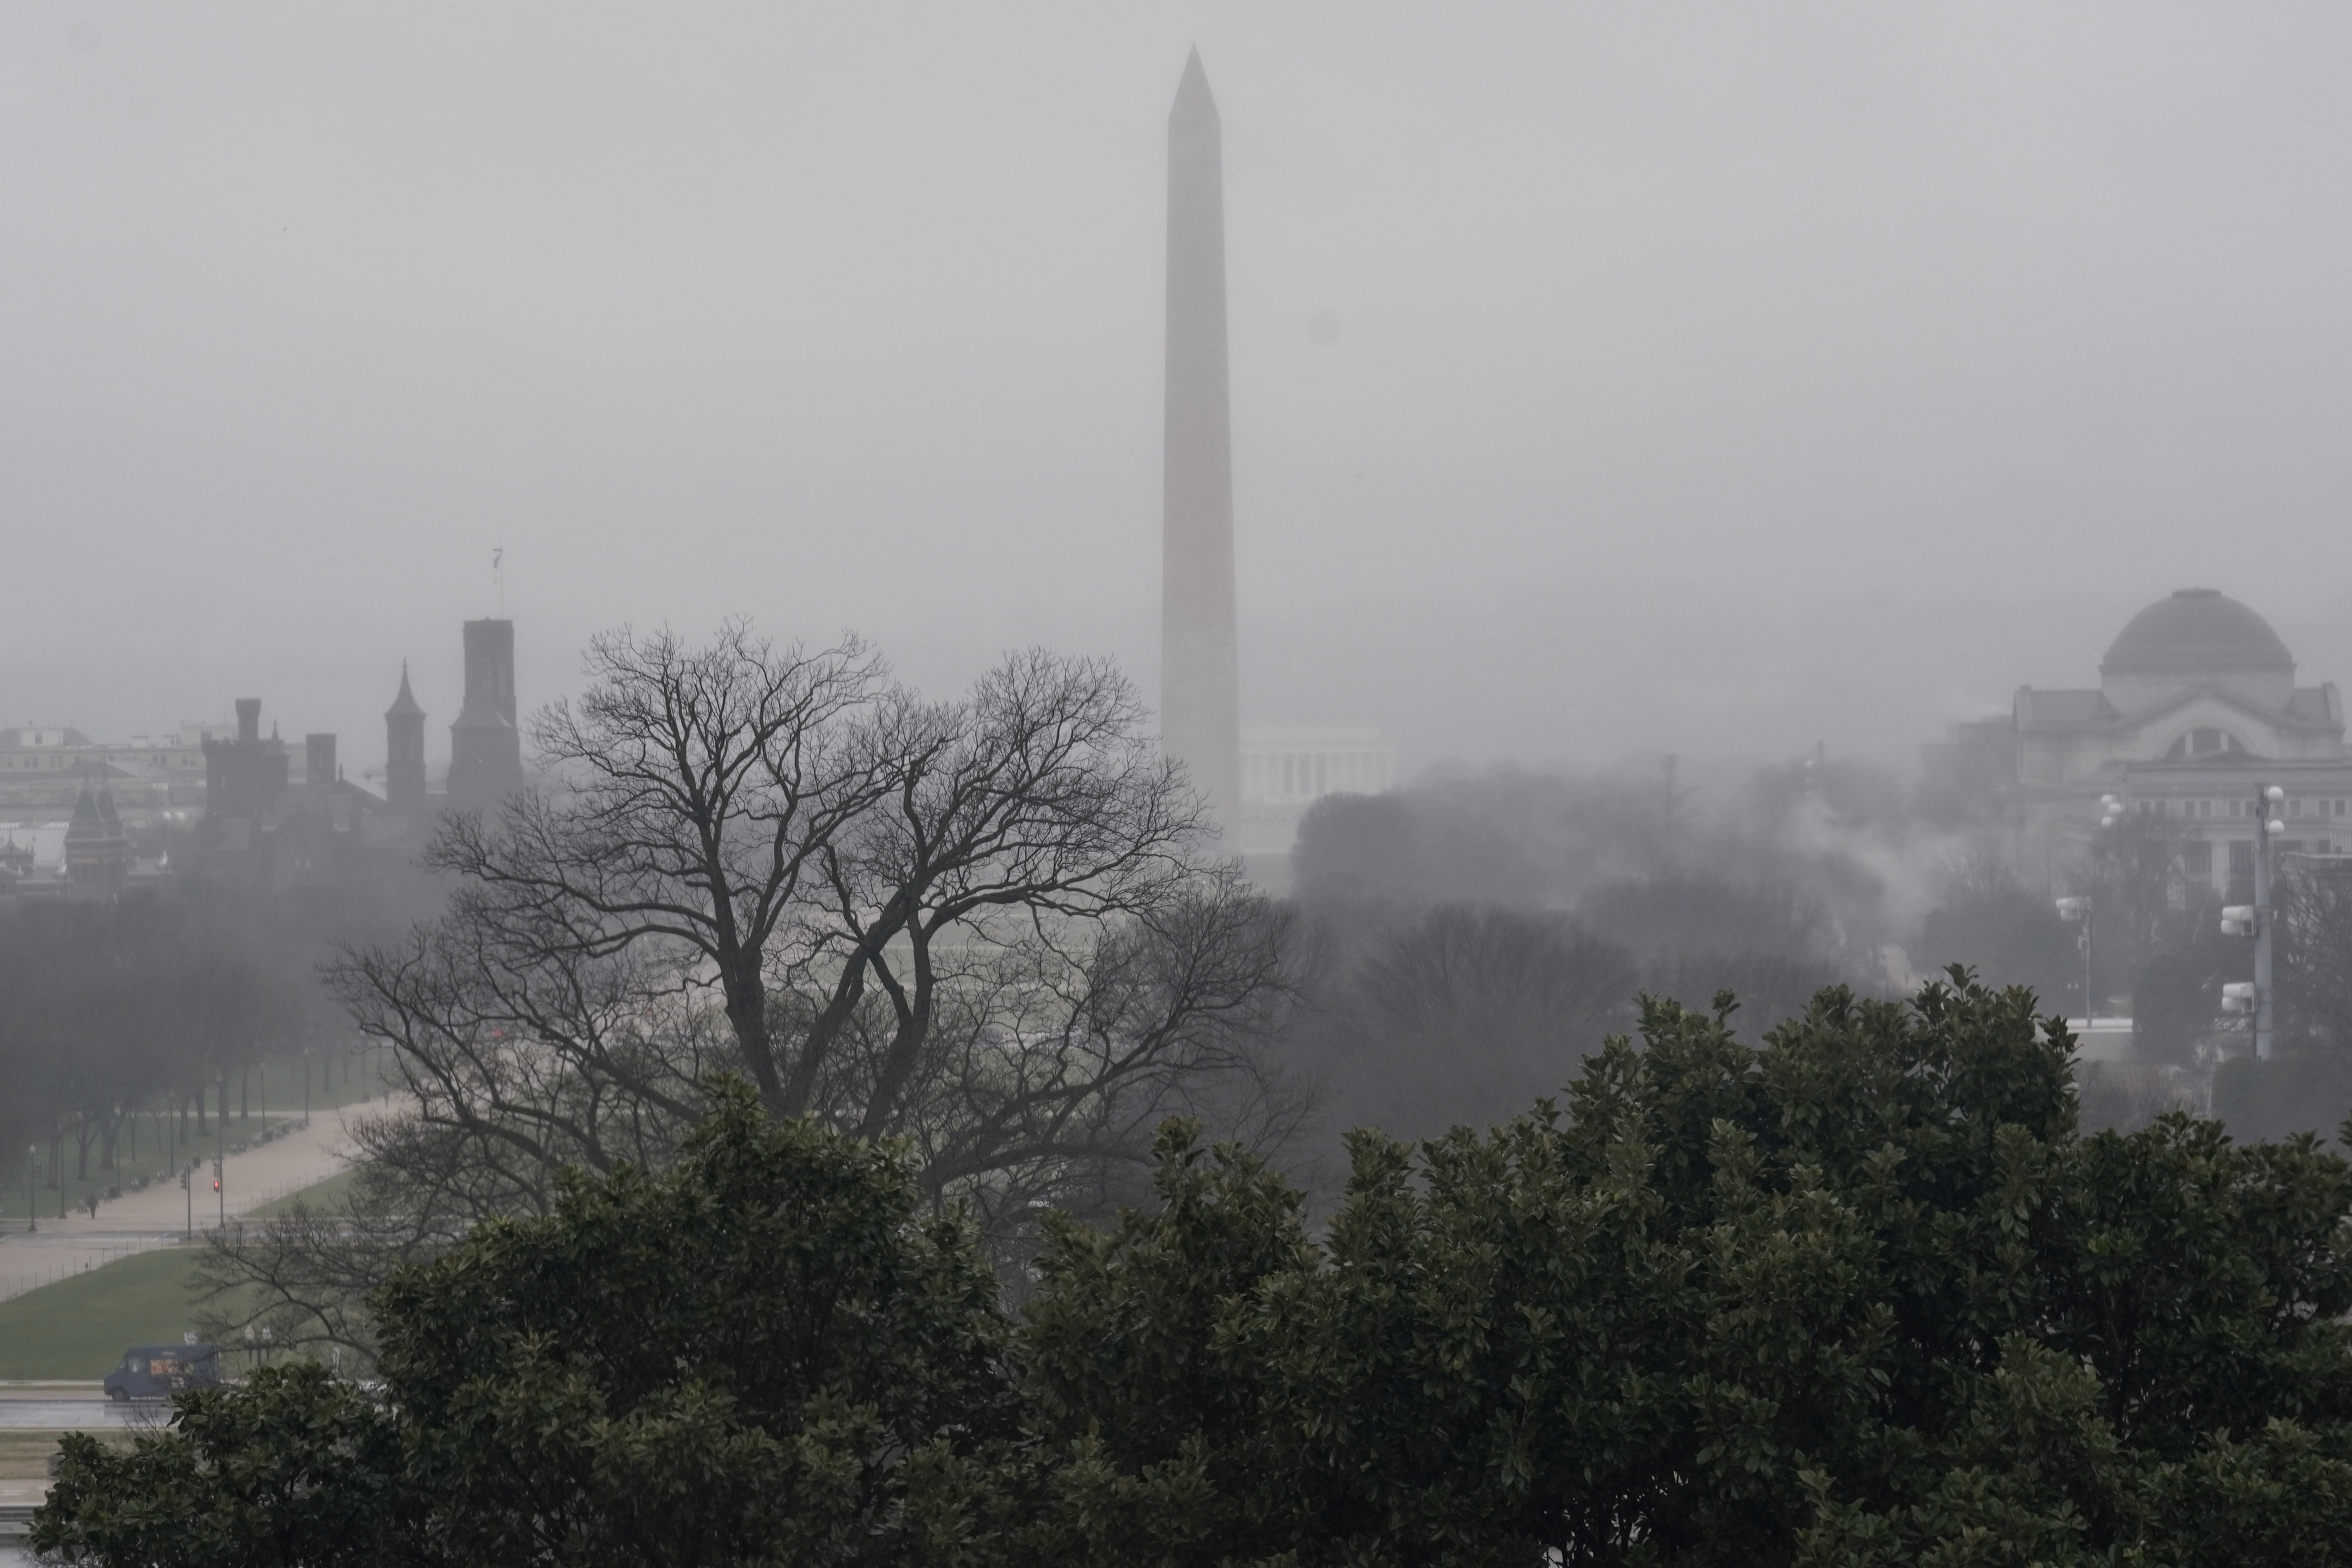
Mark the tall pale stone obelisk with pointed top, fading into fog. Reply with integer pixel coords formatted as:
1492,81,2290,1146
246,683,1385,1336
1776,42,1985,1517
1160,49,1242,832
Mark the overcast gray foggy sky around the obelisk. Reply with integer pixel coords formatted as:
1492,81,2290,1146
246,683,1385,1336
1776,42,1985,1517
0,0,2352,780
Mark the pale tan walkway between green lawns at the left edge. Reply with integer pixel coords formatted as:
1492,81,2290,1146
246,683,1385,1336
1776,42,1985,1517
0,1100,398,1300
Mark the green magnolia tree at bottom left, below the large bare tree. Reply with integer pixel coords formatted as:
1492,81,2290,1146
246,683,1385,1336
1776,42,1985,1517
35,1091,1014,1568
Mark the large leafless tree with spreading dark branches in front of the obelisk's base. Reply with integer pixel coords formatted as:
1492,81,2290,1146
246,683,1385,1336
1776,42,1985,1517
197,623,1303,1342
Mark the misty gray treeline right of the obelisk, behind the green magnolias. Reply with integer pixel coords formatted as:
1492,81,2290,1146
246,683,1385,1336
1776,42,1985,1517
1294,759,2352,1135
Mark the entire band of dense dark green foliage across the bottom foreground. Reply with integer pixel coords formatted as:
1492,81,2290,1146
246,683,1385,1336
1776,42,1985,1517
40,980,2352,1568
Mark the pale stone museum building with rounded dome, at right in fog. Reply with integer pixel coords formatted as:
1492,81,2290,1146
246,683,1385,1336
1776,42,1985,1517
2009,588,2352,893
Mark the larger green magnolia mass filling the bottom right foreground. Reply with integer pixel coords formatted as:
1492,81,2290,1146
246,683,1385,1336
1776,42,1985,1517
1023,980,2352,1566
